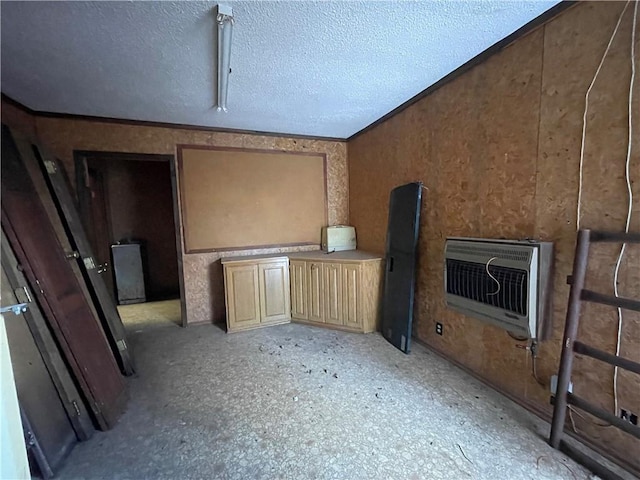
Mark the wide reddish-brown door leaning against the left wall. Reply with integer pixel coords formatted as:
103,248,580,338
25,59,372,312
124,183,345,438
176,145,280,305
1,126,126,429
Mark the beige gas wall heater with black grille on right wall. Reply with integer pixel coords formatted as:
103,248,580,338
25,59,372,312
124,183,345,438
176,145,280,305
444,238,553,341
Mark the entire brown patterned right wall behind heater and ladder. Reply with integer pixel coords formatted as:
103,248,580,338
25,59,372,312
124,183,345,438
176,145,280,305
348,2,640,468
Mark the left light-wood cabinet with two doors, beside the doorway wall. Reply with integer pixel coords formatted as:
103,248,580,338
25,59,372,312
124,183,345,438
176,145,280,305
222,256,290,332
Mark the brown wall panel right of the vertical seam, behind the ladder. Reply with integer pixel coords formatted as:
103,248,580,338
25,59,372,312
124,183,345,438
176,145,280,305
536,3,640,458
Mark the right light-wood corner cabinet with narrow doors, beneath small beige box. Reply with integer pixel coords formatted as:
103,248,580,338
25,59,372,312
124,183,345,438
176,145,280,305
289,250,383,333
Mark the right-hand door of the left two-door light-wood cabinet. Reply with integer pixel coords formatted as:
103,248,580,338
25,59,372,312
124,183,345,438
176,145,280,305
258,262,291,323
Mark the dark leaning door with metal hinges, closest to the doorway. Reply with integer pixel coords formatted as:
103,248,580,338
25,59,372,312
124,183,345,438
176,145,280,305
13,134,135,375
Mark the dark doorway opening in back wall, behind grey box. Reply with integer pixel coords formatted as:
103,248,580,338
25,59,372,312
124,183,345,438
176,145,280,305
75,152,184,312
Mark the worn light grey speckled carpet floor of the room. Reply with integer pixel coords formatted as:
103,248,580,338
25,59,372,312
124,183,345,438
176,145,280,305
58,320,616,480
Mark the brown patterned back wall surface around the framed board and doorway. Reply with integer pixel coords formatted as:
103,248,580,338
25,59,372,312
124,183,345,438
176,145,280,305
2,102,349,323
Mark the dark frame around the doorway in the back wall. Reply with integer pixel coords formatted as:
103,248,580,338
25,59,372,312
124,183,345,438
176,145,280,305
73,150,188,327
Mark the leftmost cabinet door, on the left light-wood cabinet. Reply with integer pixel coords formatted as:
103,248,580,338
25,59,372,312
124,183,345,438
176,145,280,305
224,265,260,331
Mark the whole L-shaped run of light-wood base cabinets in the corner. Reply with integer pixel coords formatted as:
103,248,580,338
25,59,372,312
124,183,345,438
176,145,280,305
222,250,383,333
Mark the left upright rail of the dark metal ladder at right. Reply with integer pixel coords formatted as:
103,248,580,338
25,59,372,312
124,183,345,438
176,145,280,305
549,230,591,448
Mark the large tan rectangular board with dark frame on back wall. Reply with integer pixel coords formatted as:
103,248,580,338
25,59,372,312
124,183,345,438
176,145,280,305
178,145,327,253
